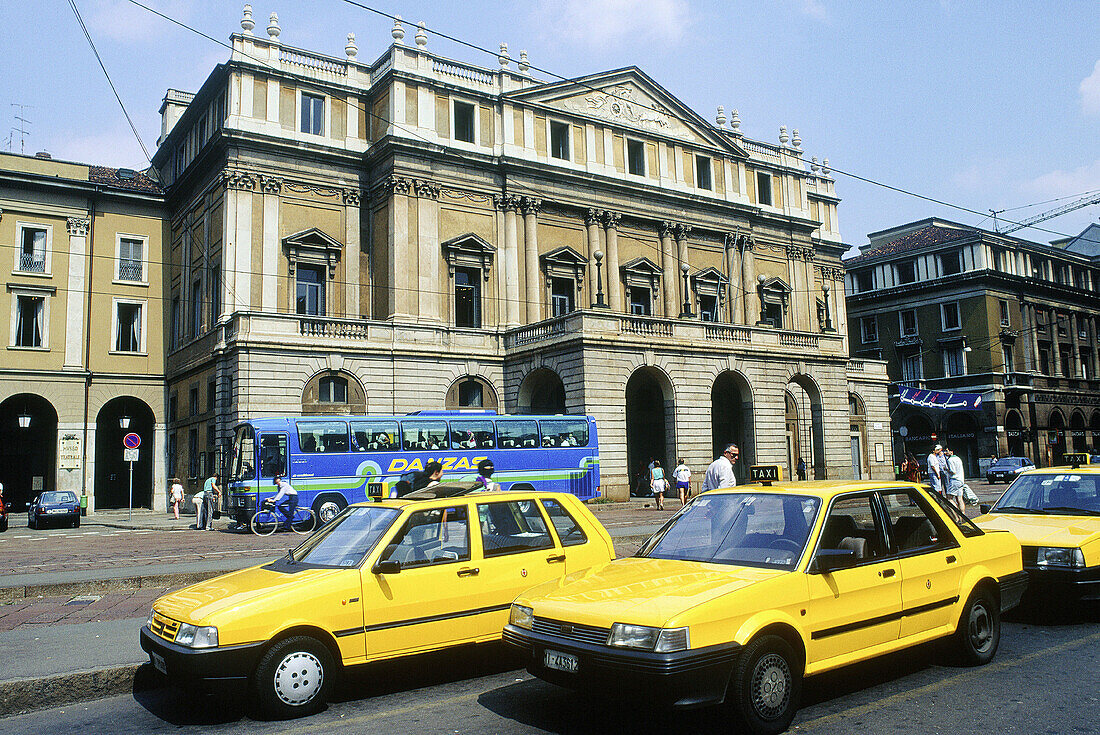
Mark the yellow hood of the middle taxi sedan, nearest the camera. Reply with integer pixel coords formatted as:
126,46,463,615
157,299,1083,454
524,558,790,627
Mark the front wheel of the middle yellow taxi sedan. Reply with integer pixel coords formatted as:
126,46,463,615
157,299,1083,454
726,636,802,735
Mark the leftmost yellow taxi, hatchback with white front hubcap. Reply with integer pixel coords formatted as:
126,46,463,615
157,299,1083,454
141,492,615,717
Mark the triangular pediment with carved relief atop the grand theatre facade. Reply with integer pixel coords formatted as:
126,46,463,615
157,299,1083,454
507,66,748,157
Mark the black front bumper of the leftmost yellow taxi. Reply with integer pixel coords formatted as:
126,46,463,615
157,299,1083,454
141,625,264,684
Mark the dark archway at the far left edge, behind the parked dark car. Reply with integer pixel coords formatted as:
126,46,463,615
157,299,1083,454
0,393,57,512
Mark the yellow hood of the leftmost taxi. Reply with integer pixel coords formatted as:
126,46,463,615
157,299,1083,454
154,566,348,624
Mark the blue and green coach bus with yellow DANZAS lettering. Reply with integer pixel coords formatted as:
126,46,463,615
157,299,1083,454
227,410,600,524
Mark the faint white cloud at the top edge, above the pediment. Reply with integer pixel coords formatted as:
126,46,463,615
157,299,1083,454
542,0,691,46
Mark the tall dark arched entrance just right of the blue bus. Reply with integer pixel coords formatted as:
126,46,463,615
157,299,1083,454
626,368,675,483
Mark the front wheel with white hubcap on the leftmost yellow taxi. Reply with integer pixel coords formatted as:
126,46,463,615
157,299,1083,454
251,636,336,720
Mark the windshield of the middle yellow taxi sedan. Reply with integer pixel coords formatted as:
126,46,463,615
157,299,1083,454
638,493,821,569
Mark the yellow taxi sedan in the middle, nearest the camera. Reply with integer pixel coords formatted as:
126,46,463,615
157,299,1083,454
504,467,1026,733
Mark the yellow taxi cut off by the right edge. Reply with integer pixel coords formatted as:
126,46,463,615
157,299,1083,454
975,454,1100,600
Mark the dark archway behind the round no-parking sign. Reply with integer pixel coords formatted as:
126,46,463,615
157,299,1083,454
92,396,158,508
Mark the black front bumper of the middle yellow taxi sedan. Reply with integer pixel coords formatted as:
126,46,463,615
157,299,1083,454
504,625,741,707
